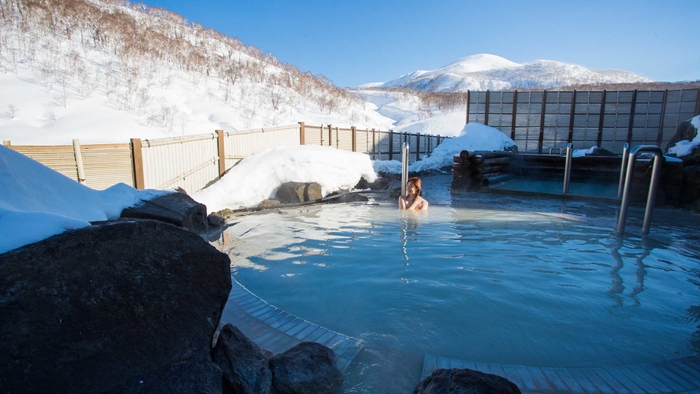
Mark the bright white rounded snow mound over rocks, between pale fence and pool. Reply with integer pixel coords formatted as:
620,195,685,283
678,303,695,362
192,145,377,212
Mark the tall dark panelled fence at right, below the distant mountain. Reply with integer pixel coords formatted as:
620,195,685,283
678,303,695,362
467,89,700,154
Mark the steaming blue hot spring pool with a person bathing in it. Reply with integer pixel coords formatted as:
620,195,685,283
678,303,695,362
219,177,700,392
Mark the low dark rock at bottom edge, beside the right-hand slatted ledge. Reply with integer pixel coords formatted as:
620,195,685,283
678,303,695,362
413,368,520,394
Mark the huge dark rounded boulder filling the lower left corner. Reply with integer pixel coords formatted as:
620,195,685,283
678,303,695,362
0,220,231,393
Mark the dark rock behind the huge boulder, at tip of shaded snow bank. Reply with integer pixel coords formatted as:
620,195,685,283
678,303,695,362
121,193,209,234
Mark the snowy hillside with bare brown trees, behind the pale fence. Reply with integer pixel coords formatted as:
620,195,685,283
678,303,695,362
0,0,394,145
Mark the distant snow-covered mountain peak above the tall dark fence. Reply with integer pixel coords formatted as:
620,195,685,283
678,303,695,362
374,54,653,92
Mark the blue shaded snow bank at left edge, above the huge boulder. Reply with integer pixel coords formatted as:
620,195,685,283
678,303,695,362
0,147,168,253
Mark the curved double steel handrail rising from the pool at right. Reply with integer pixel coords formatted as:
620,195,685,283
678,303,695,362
617,145,664,235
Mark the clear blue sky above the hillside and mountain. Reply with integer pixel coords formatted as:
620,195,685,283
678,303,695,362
139,0,700,87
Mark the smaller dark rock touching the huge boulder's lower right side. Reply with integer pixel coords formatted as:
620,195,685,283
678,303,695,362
212,324,272,394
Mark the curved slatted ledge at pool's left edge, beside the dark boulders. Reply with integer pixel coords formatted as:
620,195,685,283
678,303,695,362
221,278,363,371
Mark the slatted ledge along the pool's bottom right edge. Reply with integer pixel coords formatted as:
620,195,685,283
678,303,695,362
421,355,700,394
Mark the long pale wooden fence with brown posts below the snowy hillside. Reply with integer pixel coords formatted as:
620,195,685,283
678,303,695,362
3,122,444,192
